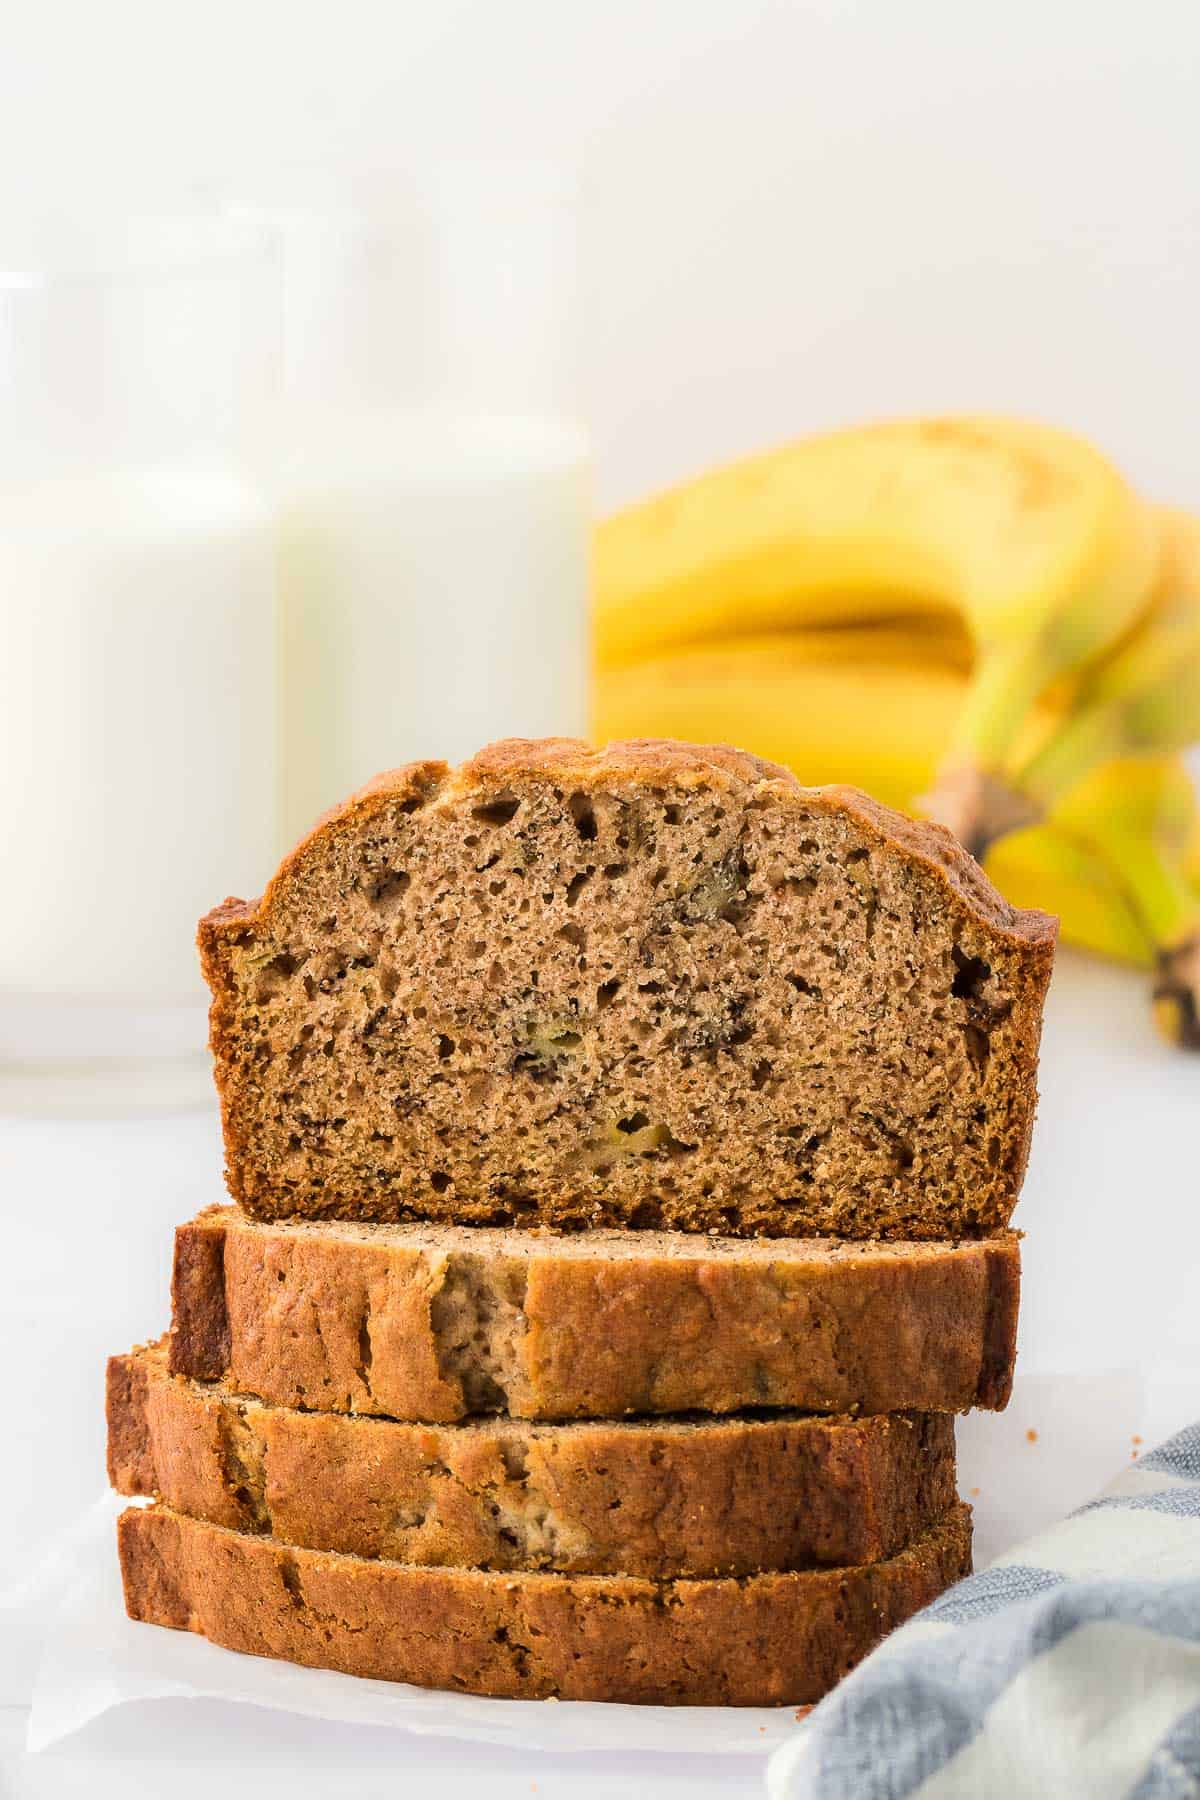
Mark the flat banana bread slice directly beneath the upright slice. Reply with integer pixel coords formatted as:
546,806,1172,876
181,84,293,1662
169,1206,1020,1420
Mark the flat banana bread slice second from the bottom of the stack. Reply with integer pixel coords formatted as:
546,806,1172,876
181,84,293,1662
108,1345,955,1579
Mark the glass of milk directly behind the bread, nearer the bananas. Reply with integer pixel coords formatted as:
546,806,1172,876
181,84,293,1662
273,164,590,837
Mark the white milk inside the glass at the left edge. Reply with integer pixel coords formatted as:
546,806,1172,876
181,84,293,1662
0,470,277,1015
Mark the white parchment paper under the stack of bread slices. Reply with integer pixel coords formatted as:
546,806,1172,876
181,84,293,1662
21,1370,1200,1755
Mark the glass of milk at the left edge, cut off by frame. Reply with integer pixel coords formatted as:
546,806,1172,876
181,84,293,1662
0,227,279,1109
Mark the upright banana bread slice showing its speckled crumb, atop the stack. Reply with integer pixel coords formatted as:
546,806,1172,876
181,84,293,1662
200,738,1054,1238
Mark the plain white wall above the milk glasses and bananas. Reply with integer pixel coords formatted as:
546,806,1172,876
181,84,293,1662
0,0,1200,504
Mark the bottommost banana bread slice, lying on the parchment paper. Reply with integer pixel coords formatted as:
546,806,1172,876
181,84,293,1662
117,1507,972,1706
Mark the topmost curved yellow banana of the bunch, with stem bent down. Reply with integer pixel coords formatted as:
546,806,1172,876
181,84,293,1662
596,418,1155,769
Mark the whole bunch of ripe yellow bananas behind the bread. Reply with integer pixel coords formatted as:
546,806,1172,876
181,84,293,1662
594,418,1200,1048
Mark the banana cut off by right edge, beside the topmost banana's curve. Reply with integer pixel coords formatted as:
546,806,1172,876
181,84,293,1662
1013,508,1200,812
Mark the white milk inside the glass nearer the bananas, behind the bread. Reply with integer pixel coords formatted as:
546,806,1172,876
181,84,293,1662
279,414,590,837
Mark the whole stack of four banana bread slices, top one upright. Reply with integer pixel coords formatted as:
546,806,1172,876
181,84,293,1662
108,740,1054,1705
